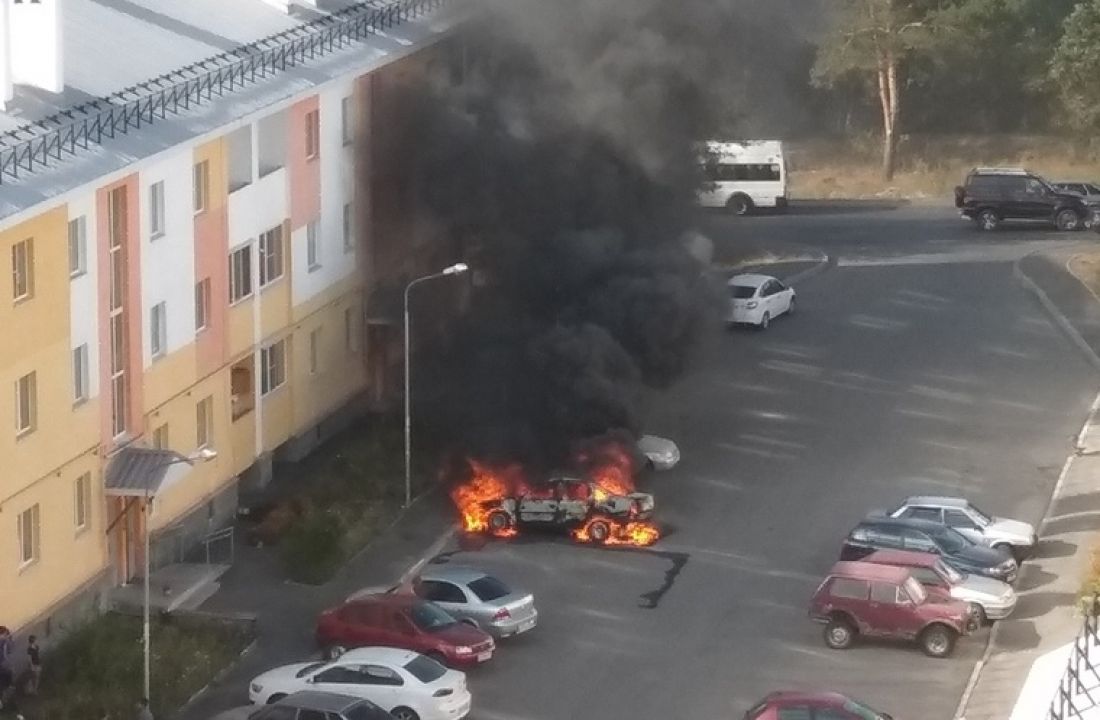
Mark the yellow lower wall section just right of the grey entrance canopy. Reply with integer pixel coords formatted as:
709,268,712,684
145,367,235,530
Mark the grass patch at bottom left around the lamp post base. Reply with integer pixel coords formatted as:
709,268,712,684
20,613,252,720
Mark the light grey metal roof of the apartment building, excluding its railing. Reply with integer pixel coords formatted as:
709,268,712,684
0,0,466,220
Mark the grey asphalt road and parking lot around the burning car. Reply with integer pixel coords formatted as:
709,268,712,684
431,208,1096,720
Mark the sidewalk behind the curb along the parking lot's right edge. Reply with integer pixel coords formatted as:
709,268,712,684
957,245,1100,720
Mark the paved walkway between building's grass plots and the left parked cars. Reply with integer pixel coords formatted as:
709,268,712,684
180,489,454,720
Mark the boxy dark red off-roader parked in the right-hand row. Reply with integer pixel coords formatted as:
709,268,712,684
810,561,975,657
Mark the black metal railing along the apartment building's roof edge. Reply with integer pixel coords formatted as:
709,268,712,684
0,0,451,185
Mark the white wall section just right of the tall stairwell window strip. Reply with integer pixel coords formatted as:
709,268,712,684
138,147,195,367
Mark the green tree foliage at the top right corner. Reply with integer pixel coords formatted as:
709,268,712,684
1051,0,1100,130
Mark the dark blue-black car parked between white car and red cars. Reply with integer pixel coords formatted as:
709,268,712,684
840,516,1019,583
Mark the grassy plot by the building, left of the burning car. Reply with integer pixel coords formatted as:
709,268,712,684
270,419,433,585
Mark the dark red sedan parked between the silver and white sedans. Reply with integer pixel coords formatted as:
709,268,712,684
317,594,496,667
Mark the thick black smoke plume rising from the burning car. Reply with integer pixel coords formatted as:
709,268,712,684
408,0,805,465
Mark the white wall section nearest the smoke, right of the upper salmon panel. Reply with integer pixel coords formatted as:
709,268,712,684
292,79,363,304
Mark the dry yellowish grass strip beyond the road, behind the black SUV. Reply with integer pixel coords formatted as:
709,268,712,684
790,135,1100,199
